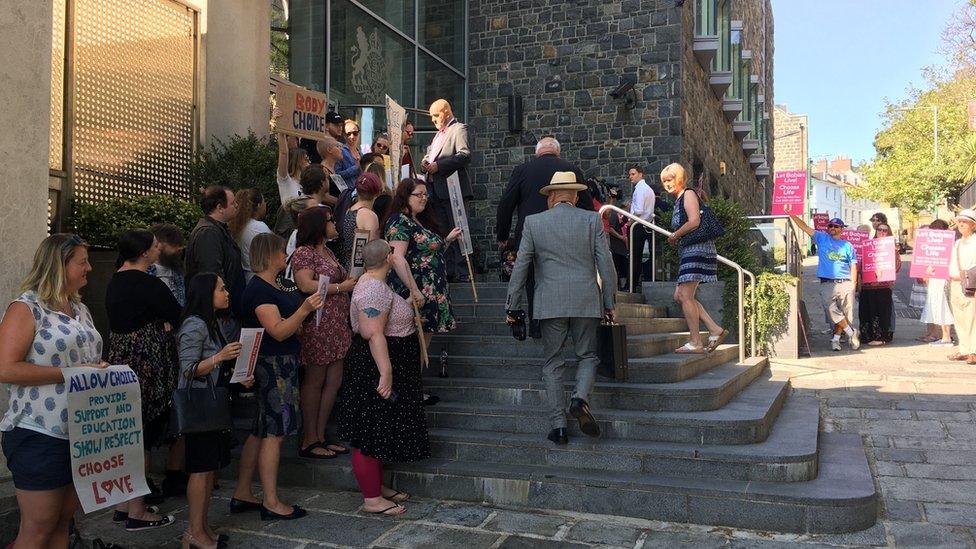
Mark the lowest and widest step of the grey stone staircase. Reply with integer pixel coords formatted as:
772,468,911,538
252,433,878,533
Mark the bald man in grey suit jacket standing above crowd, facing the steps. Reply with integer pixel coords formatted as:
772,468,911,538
420,99,473,282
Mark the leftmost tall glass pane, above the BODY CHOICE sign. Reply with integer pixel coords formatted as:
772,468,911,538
290,0,331,91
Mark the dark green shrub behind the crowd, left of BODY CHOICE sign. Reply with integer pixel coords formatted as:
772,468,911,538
190,131,281,215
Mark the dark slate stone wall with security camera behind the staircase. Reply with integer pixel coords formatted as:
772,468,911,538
466,0,773,270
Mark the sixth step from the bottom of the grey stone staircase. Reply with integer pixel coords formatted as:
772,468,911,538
428,331,708,358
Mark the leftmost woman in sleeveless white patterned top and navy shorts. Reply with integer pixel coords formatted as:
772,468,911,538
0,234,108,547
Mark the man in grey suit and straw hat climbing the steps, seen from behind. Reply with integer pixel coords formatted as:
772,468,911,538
506,172,617,444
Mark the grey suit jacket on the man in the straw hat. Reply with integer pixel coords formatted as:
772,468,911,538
506,204,617,320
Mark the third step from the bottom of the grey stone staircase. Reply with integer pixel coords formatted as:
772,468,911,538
427,379,790,444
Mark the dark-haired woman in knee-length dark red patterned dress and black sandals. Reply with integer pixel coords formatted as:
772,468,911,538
291,203,356,459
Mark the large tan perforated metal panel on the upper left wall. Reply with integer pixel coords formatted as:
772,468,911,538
72,0,197,201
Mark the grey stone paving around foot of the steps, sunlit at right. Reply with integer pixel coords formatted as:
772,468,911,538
74,261,976,549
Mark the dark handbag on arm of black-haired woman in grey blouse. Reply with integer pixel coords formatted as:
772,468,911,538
170,372,234,435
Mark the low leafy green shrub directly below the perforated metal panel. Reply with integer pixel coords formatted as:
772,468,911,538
71,194,202,248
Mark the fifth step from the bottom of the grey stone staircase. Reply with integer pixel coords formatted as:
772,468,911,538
426,339,739,383
